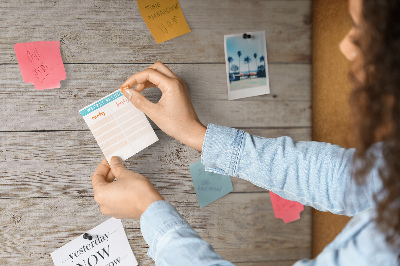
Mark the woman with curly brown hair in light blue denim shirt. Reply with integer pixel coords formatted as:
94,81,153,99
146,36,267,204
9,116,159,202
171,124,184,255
92,0,400,265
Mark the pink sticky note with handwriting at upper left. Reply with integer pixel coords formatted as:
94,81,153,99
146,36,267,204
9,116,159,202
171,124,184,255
14,41,67,90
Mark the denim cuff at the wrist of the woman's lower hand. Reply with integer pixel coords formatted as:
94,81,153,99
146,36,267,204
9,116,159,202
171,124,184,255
140,200,191,260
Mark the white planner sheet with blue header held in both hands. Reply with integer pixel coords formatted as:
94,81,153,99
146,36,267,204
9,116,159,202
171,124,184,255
79,90,158,161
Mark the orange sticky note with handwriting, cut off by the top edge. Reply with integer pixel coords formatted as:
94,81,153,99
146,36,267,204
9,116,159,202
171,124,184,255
137,0,190,43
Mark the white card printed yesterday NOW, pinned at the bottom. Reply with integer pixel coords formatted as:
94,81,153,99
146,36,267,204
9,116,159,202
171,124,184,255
51,218,138,266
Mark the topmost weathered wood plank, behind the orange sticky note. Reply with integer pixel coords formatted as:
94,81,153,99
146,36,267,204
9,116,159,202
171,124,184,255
0,0,311,63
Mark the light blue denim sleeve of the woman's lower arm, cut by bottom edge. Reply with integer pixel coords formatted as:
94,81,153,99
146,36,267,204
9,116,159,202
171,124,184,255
140,200,233,265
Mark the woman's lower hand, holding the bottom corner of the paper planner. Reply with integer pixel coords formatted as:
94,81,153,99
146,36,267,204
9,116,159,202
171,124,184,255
92,156,164,219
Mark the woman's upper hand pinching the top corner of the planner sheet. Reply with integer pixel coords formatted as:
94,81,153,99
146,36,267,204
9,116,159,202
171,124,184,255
121,62,206,151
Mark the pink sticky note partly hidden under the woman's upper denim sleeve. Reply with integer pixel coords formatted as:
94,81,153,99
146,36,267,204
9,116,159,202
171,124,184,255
269,191,304,224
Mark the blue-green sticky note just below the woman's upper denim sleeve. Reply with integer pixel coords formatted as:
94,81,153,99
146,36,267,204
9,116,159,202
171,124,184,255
190,161,233,208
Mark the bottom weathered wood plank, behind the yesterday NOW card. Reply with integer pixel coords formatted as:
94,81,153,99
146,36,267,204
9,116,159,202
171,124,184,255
0,193,311,265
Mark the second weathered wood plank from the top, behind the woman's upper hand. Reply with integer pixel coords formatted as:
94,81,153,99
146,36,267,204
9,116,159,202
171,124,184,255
0,64,311,131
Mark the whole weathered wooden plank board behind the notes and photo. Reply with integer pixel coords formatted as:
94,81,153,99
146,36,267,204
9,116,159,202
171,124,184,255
0,0,311,266
